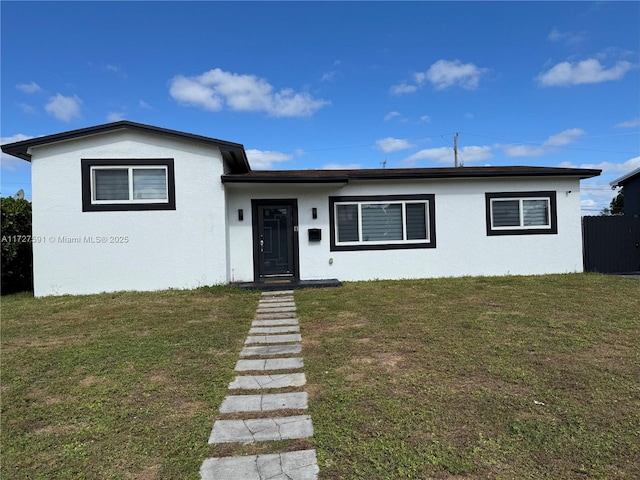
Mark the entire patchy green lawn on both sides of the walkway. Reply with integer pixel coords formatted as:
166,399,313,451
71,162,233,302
0,274,640,480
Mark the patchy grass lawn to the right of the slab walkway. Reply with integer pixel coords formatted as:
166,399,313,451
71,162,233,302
296,274,640,480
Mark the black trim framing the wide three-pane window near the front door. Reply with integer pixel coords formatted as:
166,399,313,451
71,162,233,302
329,193,436,252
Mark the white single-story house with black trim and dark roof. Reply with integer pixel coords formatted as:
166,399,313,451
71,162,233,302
2,121,600,296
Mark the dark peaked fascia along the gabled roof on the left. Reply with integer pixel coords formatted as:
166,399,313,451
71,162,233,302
2,120,251,173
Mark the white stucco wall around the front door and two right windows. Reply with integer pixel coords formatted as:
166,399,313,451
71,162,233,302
226,178,582,281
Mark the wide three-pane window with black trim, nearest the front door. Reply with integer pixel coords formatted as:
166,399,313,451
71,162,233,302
329,195,435,250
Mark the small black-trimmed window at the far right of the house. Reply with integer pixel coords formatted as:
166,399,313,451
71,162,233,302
485,192,558,235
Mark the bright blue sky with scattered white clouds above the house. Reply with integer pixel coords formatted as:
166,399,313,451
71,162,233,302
0,1,640,214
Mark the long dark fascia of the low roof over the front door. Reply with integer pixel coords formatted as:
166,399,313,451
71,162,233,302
222,167,602,184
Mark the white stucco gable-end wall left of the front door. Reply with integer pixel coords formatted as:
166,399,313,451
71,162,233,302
31,131,228,296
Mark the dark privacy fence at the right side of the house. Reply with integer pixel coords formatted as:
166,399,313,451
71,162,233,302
582,215,640,273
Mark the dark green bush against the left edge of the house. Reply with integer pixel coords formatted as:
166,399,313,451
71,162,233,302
0,197,33,295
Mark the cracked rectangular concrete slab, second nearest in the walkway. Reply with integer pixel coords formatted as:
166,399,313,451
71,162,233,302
209,415,313,444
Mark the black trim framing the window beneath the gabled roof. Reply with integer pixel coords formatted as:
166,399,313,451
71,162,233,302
80,158,176,212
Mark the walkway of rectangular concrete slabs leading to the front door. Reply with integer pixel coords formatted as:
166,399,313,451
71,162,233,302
200,290,319,480
